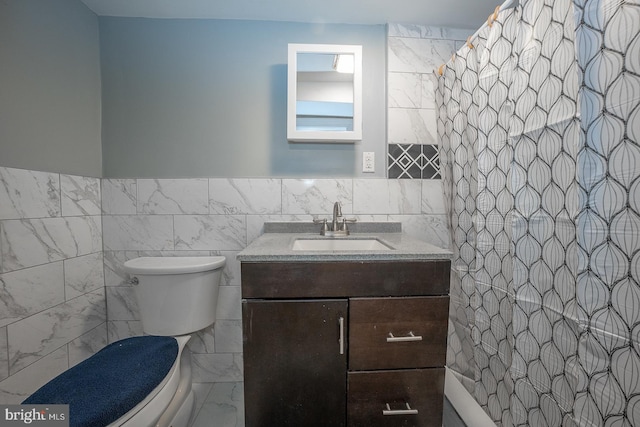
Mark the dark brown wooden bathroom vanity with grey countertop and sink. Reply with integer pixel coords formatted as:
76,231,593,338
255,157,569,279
238,226,450,427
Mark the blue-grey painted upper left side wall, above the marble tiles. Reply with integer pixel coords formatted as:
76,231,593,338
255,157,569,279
0,0,102,177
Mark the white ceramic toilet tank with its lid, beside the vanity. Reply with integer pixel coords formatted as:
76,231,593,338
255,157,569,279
124,256,226,336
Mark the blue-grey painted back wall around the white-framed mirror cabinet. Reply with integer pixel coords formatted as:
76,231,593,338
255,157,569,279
99,17,386,177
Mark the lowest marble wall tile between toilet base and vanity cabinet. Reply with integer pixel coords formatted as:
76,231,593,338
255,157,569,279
191,353,243,383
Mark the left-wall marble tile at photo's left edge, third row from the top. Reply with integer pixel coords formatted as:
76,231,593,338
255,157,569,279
0,262,64,326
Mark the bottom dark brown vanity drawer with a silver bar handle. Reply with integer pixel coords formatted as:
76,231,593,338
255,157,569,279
347,368,444,427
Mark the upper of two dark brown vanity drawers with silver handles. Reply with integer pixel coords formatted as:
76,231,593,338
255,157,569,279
349,296,449,370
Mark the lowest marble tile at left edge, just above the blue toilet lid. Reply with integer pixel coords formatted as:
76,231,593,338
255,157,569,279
0,345,69,405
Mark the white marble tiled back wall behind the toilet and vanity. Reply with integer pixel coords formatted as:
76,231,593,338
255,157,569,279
102,178,449,382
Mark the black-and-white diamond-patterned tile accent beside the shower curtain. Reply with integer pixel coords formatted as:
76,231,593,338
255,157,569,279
387,144,440,179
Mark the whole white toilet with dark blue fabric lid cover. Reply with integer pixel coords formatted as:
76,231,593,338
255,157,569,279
22,256,226,427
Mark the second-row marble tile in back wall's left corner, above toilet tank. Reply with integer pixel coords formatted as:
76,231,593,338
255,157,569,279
103,215,174,251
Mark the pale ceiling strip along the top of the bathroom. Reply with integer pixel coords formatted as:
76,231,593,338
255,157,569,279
82,0,500,29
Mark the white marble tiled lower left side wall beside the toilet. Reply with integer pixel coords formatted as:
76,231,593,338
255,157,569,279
0,167,107,403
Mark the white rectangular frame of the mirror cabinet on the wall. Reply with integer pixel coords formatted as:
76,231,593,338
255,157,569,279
287,43,362,143
